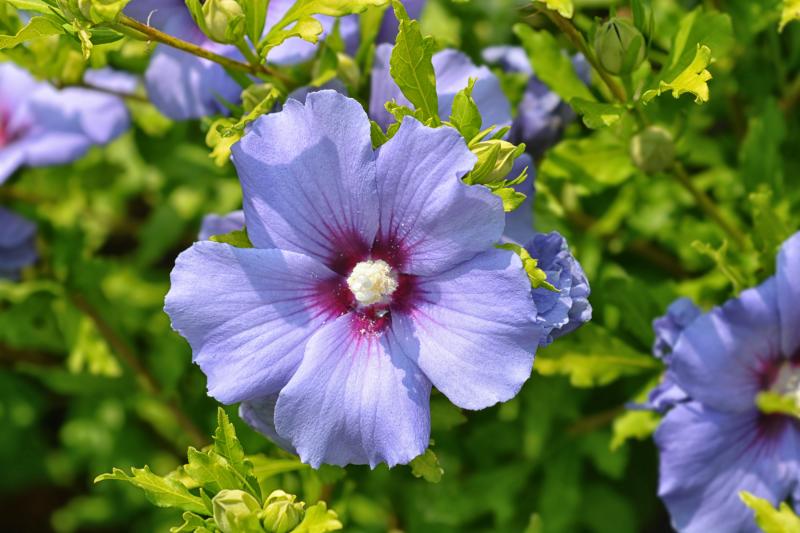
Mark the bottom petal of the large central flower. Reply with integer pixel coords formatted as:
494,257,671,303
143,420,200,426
275,314,431,468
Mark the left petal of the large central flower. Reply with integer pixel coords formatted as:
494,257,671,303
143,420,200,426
164,241,336,403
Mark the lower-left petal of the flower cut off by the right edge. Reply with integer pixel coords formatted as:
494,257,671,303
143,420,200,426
655,402,796,533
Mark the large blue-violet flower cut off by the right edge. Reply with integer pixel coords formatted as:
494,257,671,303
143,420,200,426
655,233,800,533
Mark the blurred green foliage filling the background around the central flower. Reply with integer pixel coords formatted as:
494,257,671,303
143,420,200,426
0,0,800,533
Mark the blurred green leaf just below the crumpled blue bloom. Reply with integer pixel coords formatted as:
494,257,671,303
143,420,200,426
534,324,660,388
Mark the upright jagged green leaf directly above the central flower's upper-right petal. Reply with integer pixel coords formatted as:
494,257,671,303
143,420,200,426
389,0,439,126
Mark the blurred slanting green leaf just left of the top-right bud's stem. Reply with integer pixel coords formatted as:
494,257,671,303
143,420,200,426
514,24,596,102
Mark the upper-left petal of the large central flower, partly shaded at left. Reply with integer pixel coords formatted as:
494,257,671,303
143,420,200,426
233,91,378,265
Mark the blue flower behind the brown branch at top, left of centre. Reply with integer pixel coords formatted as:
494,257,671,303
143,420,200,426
125,0,358,120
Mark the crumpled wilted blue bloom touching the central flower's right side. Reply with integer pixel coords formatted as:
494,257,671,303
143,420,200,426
525,231,592,346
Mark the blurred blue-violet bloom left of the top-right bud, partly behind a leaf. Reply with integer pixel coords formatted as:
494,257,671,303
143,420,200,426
483,46,591,158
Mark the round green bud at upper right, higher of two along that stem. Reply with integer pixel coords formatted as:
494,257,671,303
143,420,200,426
594,18,645,74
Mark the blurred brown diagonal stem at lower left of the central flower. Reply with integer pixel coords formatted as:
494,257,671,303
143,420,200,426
69,293,208,448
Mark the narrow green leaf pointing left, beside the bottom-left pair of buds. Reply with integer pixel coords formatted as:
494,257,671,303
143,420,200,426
94,466,211,516
